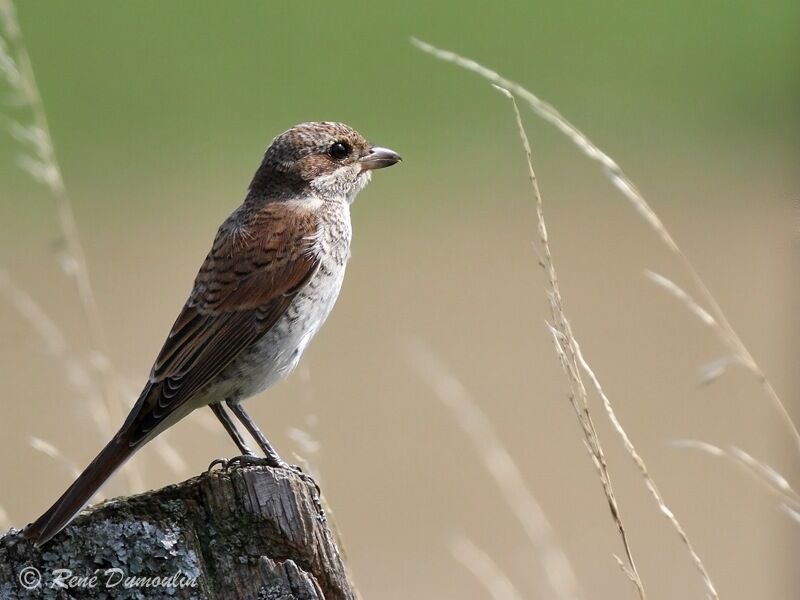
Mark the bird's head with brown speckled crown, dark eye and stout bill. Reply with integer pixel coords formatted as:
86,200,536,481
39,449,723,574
250,121,400,202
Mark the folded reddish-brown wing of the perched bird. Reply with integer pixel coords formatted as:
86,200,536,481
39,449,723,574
123,202,319,445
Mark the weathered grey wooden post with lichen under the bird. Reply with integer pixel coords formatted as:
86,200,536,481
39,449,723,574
0,467,356,600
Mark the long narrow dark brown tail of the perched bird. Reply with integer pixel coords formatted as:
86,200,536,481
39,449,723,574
22,433,139,547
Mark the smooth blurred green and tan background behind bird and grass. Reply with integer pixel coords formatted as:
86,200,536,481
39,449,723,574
0,0,800,600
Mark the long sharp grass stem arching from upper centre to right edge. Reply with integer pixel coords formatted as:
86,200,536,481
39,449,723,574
411,38,800,458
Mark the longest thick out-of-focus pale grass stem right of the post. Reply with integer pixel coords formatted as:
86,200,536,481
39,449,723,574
405,338,582,600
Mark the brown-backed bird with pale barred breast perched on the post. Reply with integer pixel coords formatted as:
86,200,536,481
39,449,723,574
23,121,401,547
